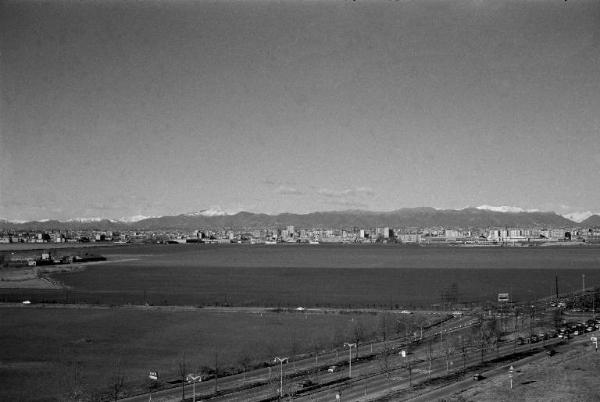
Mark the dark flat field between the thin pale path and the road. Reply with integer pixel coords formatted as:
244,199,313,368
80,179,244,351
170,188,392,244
0,308,378,401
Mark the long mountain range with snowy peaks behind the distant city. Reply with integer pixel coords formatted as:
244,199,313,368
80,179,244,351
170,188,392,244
0,207,600,231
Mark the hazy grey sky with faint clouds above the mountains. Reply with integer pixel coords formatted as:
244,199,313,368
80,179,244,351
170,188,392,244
0,0,600,220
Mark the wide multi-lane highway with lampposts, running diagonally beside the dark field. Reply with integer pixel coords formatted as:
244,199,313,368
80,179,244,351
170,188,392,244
119,310,589,402
